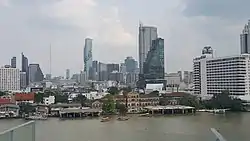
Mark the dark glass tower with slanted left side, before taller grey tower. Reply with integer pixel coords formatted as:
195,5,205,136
143,38,165,80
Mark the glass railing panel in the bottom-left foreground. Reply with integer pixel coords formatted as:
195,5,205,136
0,121,35,141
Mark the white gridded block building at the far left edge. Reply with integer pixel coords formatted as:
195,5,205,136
0,68,20,91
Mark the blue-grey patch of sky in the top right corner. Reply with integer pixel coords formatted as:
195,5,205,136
184,0,250,20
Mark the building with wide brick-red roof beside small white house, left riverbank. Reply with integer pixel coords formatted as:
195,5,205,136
15,93,35,104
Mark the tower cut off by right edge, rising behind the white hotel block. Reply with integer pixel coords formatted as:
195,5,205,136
240,20,250,54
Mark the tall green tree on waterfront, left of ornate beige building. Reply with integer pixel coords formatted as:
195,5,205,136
102,95,115,114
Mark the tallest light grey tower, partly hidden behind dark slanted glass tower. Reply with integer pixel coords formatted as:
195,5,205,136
139,24,158,74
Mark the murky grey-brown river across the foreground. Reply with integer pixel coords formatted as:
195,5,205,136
0,113,250,141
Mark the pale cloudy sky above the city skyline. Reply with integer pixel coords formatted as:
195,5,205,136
0,0,250,76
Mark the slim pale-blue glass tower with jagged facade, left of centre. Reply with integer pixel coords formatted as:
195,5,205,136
84,38,92,79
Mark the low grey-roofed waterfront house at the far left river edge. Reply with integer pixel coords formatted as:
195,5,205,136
0,104,20,118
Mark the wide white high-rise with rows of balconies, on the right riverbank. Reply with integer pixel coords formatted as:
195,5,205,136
193,46,250,98
